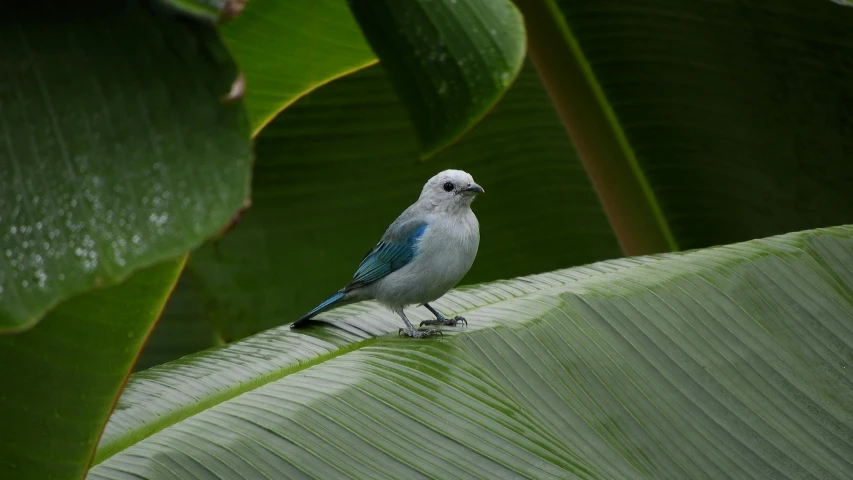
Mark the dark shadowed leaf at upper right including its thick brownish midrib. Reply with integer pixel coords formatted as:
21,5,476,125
515,0,853,254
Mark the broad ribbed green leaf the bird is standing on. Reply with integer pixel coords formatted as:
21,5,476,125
89,226,853,480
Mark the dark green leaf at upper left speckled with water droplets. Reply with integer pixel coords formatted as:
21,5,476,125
0,0,251,331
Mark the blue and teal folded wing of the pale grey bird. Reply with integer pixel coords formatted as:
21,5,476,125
344,220,427,290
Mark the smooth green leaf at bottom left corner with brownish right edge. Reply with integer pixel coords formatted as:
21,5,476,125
0,256,186,480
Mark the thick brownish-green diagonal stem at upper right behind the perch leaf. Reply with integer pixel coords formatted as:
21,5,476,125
515,0,678,256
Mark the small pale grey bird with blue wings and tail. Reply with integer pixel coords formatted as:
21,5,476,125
291,170,484,338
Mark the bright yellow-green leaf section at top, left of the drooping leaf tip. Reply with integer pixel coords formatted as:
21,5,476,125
220,0,376,131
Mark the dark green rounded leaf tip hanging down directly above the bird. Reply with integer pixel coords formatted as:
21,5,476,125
348,0,525,157
